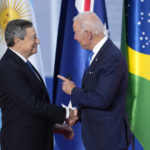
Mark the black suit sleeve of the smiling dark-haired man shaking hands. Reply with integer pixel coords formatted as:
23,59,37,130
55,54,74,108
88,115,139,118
0,68,66,123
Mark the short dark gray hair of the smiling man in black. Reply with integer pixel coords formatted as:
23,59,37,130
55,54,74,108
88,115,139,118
5,19,33,47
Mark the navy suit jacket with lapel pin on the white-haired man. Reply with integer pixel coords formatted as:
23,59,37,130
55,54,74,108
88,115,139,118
71,39,130,150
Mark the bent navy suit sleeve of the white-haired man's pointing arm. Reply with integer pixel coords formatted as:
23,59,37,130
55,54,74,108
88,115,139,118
71,54,126,109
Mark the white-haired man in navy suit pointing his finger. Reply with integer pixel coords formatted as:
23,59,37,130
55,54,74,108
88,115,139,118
58,12,130,150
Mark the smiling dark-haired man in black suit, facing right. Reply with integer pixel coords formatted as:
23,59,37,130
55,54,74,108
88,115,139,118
0,19,75,150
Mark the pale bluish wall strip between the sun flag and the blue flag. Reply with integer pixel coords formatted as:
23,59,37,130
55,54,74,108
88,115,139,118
33,0,61,77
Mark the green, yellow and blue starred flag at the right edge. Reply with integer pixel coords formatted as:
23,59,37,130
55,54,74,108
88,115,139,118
122,0,150,150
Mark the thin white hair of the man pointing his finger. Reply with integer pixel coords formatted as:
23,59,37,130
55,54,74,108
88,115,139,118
73,11,105,35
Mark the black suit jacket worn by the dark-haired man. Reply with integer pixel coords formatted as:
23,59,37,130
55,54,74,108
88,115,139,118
0,49,66,150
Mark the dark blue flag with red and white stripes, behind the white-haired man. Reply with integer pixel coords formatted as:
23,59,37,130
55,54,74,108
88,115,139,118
53,0,107,150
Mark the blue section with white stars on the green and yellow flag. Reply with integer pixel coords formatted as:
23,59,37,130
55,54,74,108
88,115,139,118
127,0,150,55
